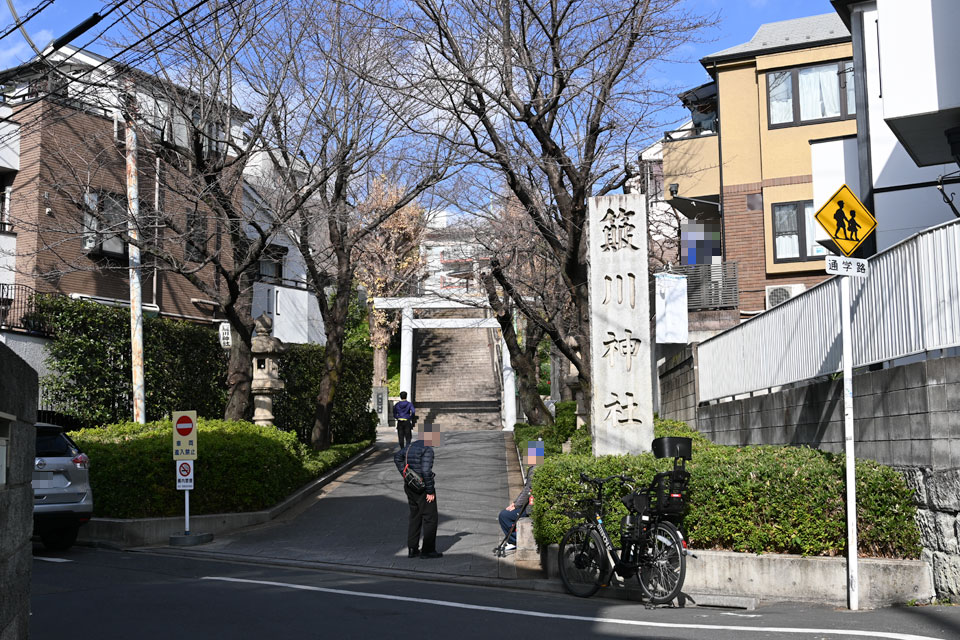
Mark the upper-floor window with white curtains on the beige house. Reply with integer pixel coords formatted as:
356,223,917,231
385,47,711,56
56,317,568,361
767,60,857,129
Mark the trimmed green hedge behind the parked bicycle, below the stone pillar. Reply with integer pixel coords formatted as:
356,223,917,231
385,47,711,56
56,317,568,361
533,419,920,558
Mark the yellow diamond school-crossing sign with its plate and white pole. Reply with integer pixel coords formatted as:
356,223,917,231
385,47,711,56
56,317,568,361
815,185,877,611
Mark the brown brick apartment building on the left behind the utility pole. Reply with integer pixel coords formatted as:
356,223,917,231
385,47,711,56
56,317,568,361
0,52,236,324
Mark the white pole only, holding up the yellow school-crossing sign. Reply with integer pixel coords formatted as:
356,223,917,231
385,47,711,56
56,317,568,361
840,276,860,611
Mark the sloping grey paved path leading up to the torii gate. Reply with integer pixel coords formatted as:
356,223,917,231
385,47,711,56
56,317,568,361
168,430,518,578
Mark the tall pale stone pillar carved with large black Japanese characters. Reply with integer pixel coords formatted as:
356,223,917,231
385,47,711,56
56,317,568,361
589,194,653,456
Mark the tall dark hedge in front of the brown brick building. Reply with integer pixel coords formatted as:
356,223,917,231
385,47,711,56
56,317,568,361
36,296,227,425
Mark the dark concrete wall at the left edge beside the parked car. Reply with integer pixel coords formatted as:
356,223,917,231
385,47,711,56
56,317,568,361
0,344,37,640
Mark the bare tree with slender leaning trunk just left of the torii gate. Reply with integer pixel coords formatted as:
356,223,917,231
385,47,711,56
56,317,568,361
258,0,458,449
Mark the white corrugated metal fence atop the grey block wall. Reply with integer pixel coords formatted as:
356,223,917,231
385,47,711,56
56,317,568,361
697,221,960,402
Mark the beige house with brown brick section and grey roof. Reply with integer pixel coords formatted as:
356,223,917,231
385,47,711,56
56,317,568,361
663,14,870,317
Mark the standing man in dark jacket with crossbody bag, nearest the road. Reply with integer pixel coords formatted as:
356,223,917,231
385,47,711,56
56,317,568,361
393,425,443,559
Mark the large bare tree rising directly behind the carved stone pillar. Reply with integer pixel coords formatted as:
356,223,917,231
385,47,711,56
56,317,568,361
405,0,706,410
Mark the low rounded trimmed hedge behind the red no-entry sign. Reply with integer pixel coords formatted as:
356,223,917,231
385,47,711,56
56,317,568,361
71,418,370,518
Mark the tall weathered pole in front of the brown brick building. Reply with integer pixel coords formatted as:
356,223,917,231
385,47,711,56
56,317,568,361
124,109,147,424
